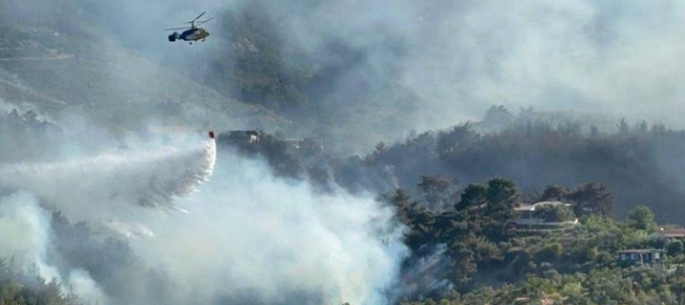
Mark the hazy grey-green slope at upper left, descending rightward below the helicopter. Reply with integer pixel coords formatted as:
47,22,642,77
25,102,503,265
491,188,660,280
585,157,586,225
0,1,288,138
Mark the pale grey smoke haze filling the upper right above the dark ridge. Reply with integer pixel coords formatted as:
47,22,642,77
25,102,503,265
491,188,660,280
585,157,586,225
264,0,685,127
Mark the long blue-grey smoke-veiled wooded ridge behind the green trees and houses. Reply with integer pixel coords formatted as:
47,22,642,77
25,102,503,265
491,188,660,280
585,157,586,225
220,107,685,223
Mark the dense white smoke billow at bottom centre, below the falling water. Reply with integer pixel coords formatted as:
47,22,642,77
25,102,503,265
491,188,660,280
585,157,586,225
132,150,406,304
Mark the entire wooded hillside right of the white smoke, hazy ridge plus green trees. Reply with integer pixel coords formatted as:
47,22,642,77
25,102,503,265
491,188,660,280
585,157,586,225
212,111,685,304
